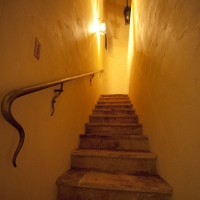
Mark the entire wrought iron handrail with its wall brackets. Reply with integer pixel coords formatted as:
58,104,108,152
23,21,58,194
1,70,103,167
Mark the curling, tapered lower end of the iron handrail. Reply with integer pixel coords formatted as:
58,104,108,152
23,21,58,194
1,91,25,167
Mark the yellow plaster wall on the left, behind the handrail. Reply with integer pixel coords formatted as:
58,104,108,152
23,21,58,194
0,0,102,200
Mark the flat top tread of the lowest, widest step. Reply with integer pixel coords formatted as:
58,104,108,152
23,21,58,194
56,169,172,194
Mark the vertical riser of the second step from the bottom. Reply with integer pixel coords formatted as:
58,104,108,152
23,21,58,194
71,153,156,174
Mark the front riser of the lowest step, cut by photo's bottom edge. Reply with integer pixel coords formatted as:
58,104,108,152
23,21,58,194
57,185,170,200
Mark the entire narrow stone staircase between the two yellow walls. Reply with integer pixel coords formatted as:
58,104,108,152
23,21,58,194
56,95,172,200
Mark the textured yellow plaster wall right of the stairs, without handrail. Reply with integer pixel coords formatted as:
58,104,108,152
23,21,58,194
129,0,200,200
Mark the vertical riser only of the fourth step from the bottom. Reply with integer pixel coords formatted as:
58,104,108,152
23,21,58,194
85,125,142,135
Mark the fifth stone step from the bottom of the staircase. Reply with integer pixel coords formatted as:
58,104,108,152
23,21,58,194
89,115,138,123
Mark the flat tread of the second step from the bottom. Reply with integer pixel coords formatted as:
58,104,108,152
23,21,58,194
71,149,157,159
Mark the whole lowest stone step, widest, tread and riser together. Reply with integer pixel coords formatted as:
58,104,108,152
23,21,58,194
56,169,172,200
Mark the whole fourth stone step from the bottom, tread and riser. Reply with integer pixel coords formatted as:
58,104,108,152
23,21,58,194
85,123,142,135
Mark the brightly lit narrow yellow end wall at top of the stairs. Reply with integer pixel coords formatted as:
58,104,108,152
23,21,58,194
102,0,130,94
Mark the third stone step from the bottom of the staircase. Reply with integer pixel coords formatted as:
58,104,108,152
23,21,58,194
79,134,149,151
